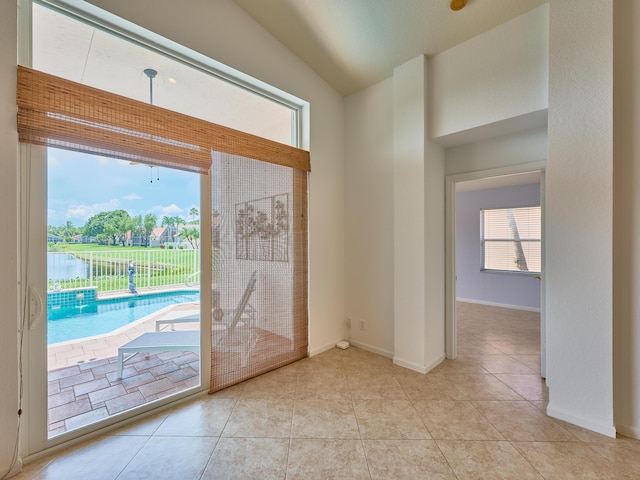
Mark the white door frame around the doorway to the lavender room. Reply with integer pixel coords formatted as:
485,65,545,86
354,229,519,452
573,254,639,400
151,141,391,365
445,161,548,378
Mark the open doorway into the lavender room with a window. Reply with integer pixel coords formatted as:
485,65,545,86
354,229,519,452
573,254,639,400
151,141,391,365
446,163,546,377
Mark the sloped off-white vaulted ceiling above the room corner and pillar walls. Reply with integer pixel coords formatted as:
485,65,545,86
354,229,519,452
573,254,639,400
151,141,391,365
234,0,548,95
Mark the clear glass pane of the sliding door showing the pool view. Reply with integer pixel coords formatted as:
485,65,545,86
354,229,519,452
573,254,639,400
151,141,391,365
46,149,201,438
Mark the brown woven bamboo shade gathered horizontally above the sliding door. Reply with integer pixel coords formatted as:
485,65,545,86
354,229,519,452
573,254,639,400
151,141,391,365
16,66,311,174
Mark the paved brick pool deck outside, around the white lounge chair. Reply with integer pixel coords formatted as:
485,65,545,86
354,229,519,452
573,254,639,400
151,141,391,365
48,303,200,436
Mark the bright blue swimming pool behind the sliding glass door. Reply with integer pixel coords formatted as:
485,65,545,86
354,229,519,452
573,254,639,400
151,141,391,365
47,290,200,344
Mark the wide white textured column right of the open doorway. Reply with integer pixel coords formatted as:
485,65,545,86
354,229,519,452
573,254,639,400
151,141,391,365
546,0,615,435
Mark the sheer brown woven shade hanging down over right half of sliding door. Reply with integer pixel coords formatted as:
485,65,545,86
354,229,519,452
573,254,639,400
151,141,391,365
211,153,308,392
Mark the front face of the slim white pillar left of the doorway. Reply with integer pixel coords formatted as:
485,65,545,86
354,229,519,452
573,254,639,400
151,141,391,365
391,56,427,371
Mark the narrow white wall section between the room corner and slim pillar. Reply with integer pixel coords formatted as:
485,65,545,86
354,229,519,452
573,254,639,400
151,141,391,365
345,79,394,357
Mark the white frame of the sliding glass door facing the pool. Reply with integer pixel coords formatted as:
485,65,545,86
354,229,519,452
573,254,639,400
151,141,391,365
20,144,212,461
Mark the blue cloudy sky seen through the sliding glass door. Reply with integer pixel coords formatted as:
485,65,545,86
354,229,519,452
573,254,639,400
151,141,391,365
47,148,200,227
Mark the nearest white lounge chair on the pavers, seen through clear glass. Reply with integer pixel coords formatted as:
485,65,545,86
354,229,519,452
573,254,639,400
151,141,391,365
118,330,200,378
